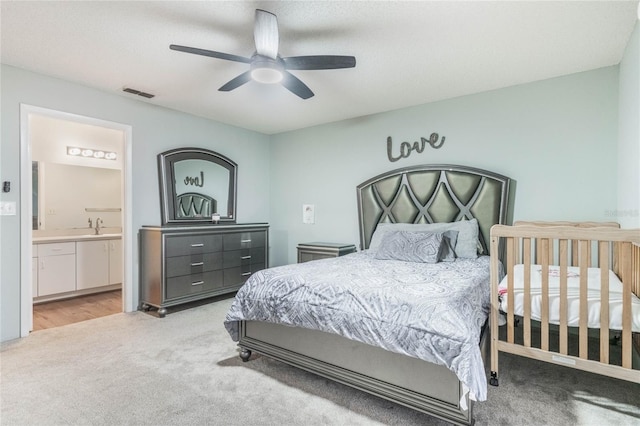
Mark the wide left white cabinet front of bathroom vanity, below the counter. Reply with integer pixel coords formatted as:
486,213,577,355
37,242,76,296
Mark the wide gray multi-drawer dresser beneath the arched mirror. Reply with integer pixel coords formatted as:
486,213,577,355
139,223,269,317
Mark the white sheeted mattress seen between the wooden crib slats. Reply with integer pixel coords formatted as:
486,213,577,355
498,264,640,333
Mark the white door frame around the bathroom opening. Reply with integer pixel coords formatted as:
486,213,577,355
20,104,134,337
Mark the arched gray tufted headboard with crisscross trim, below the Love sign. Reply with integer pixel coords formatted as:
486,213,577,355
357,165,511,253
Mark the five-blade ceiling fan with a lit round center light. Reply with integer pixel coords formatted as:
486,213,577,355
169,9,356,99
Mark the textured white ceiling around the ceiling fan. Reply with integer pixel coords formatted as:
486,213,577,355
0,0,638,134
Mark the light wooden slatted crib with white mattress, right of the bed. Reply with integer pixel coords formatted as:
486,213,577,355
489,222,640,386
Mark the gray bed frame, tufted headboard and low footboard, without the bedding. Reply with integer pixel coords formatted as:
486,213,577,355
238,165,511,424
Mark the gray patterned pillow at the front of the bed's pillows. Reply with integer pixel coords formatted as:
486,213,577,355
374,231,444,263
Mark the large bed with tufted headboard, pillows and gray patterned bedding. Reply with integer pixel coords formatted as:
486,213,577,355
225,165,511,424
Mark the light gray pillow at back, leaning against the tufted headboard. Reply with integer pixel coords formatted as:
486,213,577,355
369,219,478,259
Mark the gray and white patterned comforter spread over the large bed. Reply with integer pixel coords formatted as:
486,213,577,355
225,251,490,401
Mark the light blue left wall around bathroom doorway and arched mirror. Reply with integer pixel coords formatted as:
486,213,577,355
0,65,270,341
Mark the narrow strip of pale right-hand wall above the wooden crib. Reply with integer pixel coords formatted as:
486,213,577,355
612,21,640,228
